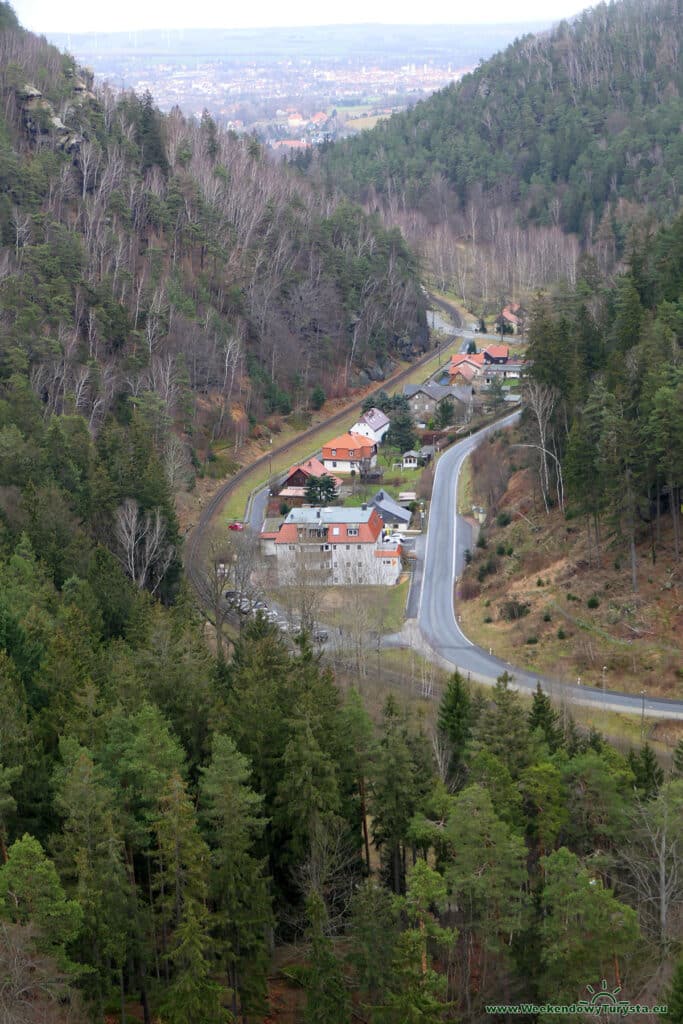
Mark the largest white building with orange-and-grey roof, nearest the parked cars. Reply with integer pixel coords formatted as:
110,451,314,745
261,505,402,586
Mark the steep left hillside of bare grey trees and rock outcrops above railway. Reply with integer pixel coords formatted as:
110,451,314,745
0,4,426,453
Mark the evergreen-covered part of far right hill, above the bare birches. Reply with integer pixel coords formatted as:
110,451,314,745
326,0,683,245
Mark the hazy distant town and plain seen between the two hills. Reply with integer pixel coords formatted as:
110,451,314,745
46,25,539,153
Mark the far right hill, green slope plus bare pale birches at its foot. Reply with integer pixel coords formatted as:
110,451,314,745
309,0,683,314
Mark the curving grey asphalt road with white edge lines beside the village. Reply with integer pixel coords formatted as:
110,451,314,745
418,412,683,719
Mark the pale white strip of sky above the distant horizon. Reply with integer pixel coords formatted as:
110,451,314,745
11,0,590,32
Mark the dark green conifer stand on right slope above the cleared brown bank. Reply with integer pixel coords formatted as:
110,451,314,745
526,211,683,591
